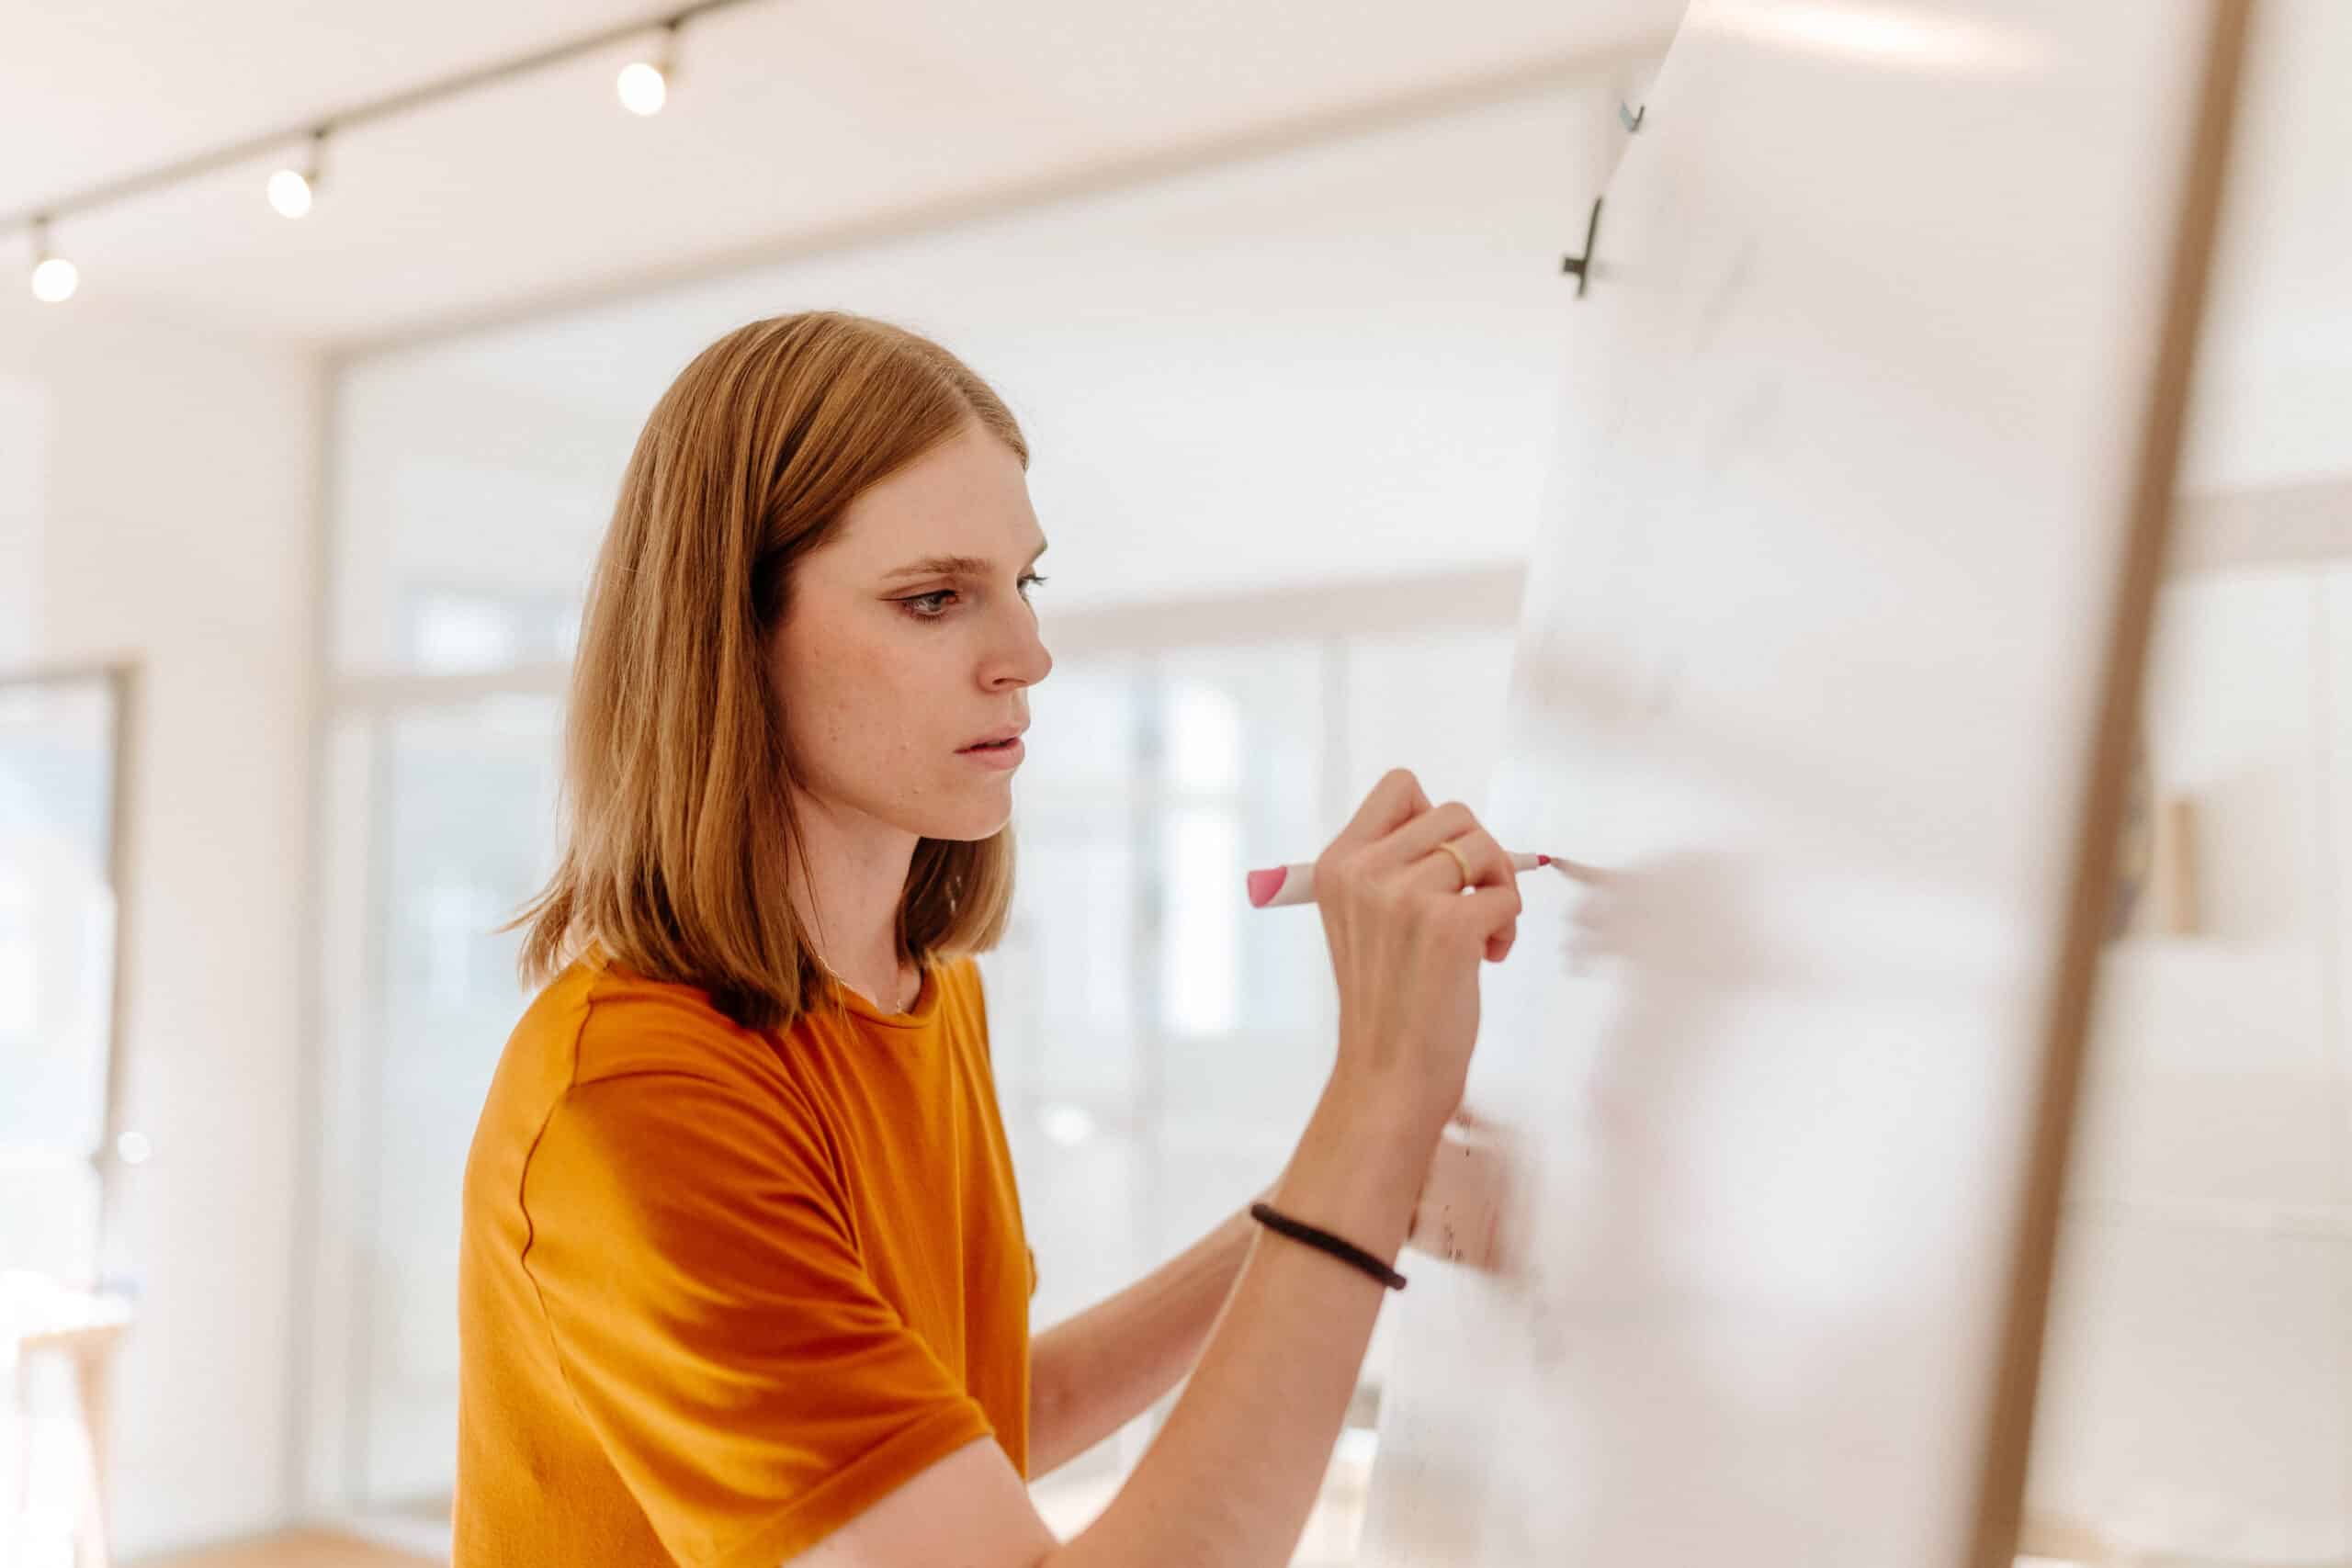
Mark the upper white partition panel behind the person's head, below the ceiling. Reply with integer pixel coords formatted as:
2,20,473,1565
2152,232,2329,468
334,85,1623,670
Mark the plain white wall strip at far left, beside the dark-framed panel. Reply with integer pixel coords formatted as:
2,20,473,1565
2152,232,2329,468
0,289,322,1556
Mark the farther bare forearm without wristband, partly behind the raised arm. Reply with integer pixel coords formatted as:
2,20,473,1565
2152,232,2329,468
1030,1187,1272,1479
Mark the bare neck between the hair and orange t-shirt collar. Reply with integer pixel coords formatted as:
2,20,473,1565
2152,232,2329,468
788,795,920,1013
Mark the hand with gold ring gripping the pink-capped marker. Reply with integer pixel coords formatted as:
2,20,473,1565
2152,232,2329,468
1315,769,1520,1138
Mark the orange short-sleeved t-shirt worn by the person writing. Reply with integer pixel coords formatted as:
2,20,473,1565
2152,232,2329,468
457,959,1035,1568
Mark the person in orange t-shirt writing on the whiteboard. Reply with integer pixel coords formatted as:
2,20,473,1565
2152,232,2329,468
457,312,1520,1568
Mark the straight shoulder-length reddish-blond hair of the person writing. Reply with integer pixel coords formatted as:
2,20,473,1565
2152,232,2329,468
505,310,1028,1030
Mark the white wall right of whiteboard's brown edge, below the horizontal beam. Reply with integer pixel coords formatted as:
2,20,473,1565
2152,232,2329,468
2028,564,2352,1563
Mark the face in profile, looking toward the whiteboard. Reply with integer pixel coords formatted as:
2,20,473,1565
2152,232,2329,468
769,423,1054,840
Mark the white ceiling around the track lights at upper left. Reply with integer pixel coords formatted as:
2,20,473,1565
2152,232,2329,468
0,0,1681,345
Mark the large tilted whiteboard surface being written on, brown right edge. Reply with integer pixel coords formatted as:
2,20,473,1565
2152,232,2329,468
1362,0,2242,1568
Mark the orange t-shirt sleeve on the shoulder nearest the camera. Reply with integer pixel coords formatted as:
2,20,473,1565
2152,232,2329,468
522,1072,992,1568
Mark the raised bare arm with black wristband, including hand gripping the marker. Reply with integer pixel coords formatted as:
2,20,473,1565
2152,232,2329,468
799,769,1520,1568
